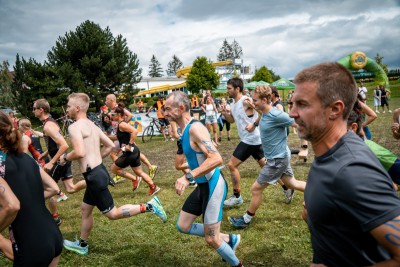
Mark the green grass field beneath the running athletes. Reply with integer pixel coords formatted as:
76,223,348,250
0,80,400,267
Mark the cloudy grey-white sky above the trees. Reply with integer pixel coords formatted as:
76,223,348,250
0,0,400,78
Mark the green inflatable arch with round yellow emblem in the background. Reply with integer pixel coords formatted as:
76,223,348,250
337,51,390,89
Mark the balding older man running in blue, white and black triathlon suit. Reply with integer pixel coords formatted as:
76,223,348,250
165,91,242,266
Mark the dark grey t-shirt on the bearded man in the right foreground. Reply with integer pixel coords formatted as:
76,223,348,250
304,132,400,267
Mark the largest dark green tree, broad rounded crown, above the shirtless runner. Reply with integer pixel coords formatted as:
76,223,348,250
44,20,142,108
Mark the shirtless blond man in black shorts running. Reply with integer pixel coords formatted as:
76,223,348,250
62,93,167,255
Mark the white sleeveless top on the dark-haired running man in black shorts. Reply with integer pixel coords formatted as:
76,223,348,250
231,96,261,145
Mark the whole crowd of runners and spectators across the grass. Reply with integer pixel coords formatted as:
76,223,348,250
0,63,400,267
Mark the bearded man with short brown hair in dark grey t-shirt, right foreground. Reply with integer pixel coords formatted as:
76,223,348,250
290,63,400,266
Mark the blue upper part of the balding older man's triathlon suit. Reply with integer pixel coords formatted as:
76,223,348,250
180,120,220,184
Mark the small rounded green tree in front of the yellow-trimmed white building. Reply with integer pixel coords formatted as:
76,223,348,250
186,57,219,94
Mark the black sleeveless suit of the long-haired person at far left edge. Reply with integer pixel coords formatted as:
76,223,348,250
0,153,63,266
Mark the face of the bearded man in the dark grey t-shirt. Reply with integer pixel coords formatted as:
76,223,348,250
289,82,329,143
